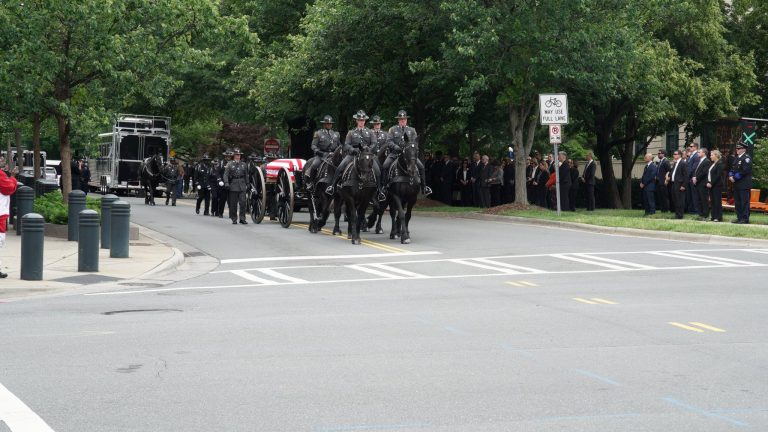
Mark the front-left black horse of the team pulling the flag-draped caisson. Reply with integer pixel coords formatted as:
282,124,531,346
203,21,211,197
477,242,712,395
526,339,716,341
334,147,377,244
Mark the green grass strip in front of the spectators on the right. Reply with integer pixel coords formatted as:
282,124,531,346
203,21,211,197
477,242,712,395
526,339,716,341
414,206,768,239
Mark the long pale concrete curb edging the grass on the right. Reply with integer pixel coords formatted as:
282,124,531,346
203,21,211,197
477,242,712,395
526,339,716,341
416,211,768,248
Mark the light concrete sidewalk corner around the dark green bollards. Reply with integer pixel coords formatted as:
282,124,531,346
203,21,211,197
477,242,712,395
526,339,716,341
0,224,184,302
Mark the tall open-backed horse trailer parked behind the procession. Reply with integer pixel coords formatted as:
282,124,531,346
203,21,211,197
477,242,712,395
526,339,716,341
88,114,171,195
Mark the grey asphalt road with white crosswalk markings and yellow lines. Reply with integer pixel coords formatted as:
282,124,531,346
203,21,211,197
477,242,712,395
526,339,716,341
0,197,768,432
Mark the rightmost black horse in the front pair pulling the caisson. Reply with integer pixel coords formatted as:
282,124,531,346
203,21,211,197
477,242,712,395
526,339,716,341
387,143,421,244
